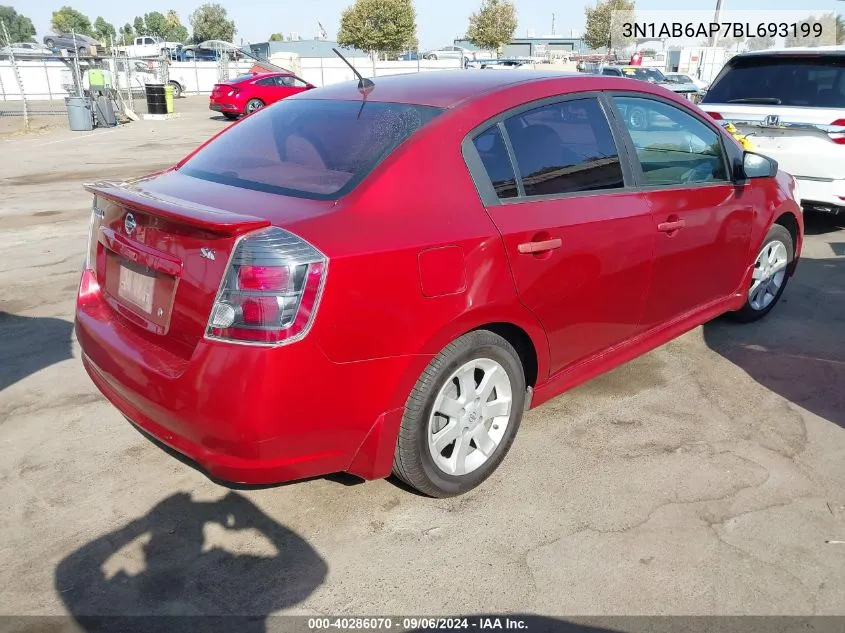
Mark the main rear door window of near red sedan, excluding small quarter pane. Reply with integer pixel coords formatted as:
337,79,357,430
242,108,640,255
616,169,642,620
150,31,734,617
505,99,624,196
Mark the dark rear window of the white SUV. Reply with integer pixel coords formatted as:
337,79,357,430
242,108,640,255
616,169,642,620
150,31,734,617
702,56,845,108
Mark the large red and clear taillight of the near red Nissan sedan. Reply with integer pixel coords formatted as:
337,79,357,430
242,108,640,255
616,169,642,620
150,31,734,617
206,227,328,345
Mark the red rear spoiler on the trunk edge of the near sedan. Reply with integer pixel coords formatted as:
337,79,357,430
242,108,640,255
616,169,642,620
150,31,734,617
83,181,270,235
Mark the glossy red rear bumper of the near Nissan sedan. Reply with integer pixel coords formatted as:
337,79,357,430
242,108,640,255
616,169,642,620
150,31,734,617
76,273,414,484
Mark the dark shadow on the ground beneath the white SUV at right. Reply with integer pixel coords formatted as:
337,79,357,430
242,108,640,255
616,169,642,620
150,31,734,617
704,252,845,429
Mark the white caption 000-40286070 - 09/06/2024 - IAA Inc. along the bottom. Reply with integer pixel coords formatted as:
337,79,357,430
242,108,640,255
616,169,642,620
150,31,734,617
308,616,528,631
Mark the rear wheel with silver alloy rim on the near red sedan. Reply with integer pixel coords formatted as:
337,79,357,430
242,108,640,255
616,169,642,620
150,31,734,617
393,330,526,498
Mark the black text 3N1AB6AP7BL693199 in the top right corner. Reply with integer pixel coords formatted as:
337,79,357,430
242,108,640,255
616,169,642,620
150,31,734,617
622,22,824,39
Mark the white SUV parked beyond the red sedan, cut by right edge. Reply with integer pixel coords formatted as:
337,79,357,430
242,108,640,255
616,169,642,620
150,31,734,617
700,46,845,213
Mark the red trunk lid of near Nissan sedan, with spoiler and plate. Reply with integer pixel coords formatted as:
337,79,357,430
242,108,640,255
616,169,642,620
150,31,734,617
86,171,334,359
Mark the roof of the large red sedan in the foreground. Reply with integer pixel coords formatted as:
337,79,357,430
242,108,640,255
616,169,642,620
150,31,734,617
300,69,585,108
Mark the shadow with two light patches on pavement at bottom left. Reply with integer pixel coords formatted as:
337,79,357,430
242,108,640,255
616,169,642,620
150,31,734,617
55,492,328,633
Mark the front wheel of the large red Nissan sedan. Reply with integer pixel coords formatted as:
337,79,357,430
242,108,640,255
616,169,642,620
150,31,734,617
730,224,795,323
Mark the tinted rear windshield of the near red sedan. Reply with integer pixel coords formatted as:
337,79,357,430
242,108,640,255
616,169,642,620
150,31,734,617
181,99,443,200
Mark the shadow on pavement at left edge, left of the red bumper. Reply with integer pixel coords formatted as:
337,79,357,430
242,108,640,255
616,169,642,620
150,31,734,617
0,311,73,391
